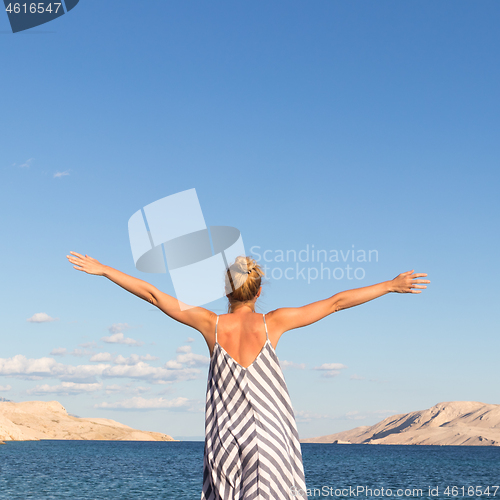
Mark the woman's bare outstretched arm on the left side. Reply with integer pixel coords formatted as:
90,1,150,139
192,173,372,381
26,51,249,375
66,252,216,336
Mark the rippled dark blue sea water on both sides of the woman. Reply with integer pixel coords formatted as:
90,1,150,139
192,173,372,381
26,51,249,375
0,441,500,500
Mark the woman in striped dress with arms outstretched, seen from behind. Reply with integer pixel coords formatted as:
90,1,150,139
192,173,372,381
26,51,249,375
67,252,430,500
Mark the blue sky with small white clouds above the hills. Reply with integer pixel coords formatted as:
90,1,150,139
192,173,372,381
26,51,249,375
0,0,500,438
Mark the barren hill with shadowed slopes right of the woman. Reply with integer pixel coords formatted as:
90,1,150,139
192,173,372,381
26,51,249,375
300,401,500,446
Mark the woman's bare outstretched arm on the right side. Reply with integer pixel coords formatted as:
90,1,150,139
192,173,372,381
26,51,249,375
268,270,430,335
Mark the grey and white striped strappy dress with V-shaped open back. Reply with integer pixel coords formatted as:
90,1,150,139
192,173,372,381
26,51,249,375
201,315,307,500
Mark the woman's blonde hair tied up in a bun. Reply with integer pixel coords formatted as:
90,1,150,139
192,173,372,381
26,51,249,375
225,256,264,313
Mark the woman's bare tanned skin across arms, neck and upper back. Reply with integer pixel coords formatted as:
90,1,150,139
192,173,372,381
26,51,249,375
66,252,430,367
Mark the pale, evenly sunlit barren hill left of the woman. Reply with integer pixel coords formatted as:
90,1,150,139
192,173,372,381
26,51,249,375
0,401,176,441
